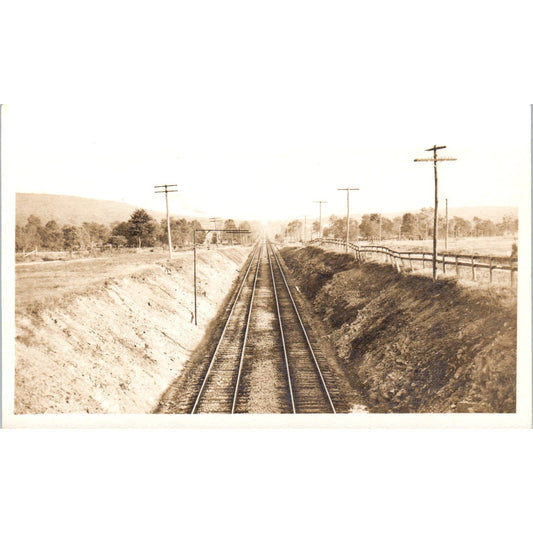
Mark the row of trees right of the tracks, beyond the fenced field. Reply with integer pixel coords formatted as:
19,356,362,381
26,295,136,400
276,207,518,241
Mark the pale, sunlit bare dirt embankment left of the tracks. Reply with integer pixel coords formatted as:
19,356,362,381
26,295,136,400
15,247,250,414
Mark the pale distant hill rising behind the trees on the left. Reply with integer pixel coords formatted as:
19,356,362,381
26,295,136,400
16,192,194,226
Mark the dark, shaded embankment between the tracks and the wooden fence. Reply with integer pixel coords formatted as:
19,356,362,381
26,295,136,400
283,247,516,413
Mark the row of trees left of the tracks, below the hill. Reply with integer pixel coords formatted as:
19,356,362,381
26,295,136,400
15,209,254,252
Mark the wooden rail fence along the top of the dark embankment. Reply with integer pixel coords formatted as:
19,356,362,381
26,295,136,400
309,239,518,286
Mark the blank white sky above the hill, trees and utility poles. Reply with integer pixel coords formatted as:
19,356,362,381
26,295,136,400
0,1,533,220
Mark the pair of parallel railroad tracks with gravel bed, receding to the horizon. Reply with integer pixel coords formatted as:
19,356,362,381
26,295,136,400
158,242,346,414
